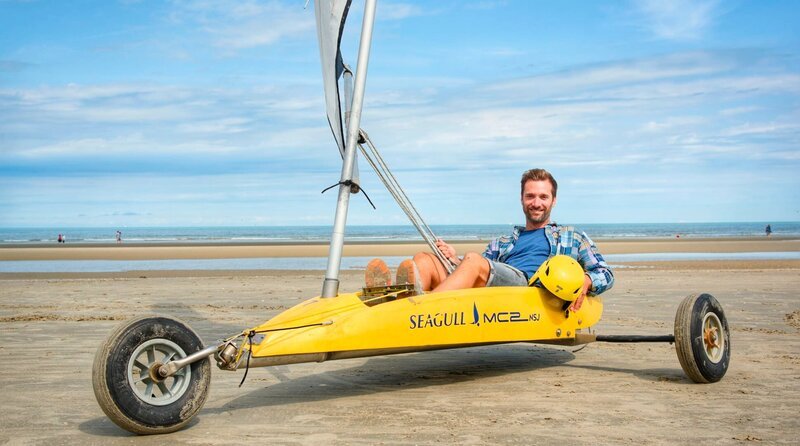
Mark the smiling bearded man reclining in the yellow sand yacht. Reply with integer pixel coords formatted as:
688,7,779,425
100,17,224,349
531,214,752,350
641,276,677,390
366,169,614,311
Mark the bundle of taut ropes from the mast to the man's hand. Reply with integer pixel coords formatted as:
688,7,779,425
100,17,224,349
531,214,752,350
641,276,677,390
358,129,456,273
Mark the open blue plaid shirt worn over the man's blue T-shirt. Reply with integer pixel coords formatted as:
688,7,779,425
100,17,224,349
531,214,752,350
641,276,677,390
483,223,614,296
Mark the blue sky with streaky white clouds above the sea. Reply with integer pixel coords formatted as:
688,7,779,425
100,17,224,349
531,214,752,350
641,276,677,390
0,0,800,227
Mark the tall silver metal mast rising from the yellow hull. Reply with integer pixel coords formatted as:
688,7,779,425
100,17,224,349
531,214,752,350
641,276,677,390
322,0,377,297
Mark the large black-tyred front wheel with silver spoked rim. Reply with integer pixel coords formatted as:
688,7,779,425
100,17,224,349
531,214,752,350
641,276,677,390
92,316,211,434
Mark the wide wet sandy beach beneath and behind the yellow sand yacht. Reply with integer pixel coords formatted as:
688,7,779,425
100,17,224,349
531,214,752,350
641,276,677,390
0,239,800,445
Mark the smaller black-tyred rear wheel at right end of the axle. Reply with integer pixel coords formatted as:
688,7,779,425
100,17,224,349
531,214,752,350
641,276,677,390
675,294,731,383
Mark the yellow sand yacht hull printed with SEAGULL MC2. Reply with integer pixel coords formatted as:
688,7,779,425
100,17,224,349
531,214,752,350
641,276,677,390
243,287,603,367
